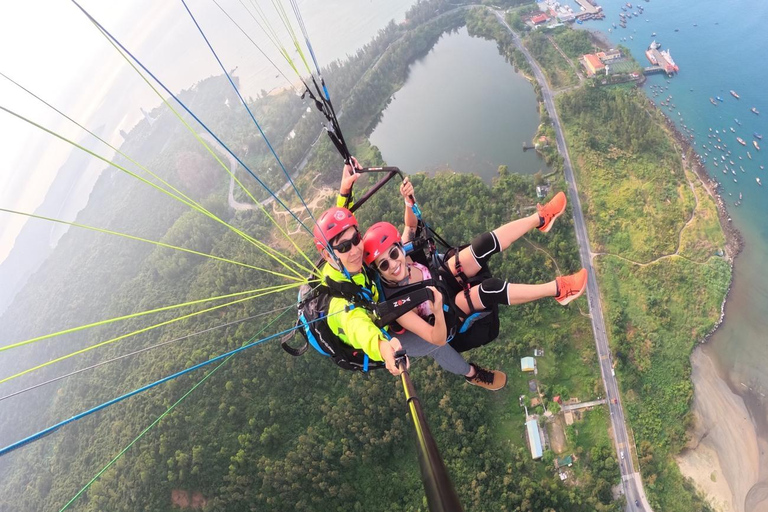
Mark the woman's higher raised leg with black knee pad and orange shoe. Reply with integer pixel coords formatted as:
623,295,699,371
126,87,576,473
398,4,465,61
448,192,567,277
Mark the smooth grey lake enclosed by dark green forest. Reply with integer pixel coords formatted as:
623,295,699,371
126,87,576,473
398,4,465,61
370,27,549,181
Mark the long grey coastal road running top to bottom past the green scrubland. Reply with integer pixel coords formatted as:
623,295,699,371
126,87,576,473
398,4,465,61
494,11,651,512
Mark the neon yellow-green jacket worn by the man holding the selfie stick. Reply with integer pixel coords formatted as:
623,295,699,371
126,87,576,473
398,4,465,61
320,263,385,361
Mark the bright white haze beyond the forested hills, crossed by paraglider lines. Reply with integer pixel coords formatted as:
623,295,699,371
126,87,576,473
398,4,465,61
0,0,415,263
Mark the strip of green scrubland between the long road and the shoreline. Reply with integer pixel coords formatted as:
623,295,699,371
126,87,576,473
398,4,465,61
558,77,730,511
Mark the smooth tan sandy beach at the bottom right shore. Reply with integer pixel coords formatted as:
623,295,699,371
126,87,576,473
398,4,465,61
677,347,759,512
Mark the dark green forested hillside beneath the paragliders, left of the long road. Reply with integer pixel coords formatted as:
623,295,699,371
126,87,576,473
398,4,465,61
0,1,617,512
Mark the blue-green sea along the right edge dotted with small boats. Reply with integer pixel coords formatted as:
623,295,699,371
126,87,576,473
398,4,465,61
574,0,768,511
